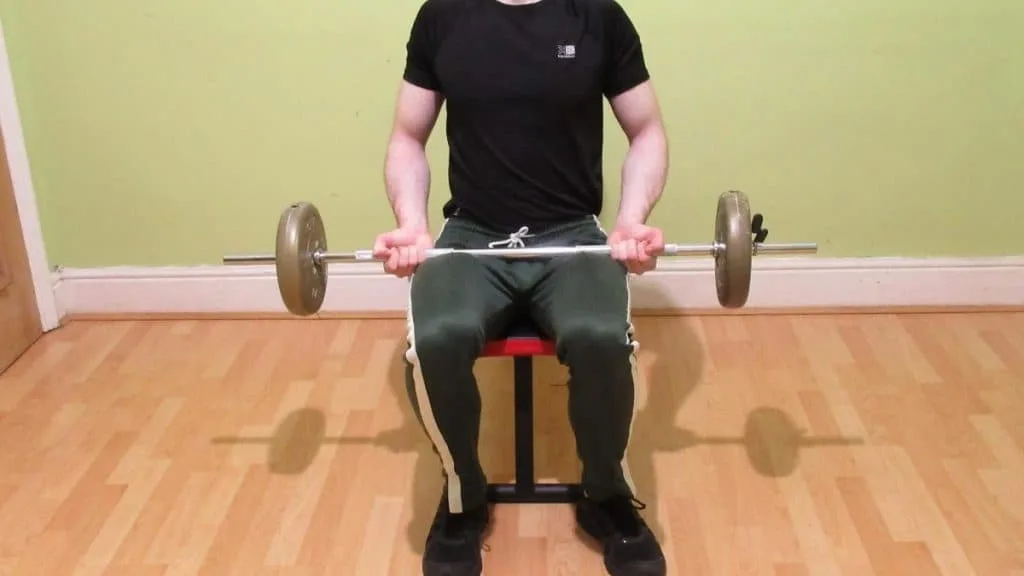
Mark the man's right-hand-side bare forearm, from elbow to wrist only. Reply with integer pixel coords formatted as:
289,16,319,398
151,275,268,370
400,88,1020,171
616,123,669,225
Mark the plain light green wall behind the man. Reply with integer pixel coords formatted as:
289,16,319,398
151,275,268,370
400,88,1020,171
0,0,1024,266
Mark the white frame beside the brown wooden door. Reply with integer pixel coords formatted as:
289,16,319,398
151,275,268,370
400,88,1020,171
0,15,60,332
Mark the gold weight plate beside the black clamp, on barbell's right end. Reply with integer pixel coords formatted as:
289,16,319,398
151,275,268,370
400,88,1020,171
715,191,754,308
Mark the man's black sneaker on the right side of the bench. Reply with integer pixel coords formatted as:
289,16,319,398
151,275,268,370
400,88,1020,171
575,496,668,576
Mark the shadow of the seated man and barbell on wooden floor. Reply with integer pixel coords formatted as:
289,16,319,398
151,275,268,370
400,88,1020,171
212,301,863,554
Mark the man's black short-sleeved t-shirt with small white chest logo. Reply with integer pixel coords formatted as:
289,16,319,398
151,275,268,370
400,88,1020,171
403,0,649,231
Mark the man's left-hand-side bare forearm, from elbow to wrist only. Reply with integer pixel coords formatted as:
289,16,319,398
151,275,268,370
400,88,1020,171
384,135,430,232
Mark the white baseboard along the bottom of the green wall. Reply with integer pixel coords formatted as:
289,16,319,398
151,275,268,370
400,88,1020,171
54,256,1024,317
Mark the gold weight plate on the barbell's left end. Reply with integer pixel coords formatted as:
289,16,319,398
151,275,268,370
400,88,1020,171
276,202,327,316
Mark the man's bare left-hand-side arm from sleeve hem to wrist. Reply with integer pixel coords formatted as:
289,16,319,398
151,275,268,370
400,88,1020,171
384,80,443,232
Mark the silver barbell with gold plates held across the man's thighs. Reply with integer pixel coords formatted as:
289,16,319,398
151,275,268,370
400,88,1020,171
223,191,818,316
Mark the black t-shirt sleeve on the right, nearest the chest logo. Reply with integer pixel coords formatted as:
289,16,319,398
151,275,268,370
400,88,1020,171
604,0,650,98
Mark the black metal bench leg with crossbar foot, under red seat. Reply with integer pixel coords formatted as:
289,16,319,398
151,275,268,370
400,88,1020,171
487,357,583,504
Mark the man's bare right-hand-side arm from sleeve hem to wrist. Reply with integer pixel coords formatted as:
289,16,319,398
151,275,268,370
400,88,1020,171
611,80,669,225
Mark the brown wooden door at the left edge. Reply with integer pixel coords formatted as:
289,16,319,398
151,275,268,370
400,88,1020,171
0,123,43,372
